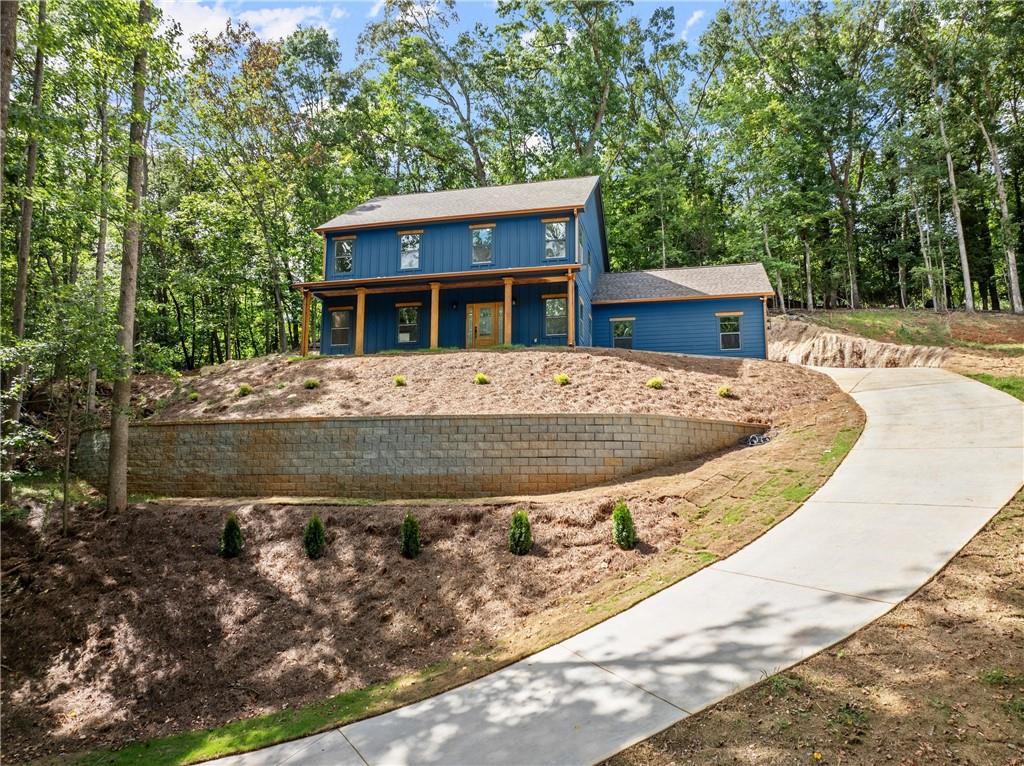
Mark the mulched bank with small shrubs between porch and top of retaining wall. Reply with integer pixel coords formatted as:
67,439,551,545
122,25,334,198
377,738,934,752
154,348,833,423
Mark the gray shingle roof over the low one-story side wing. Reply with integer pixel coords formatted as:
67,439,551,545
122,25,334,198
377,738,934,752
594,263,772,302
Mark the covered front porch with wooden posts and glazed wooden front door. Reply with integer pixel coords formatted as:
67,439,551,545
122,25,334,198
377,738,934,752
293,264,580,355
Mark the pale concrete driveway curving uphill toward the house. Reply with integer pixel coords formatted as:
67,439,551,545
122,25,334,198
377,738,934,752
211,368,1024,766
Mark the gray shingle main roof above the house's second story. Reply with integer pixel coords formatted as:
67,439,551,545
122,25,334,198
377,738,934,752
316,175,598,231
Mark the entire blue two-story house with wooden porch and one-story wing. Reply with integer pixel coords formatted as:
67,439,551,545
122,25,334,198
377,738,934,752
293,176,772,357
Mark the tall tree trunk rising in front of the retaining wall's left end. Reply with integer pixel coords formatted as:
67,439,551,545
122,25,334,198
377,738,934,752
106,0,151,512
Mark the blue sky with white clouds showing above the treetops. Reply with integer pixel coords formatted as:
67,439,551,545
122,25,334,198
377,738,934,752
157,0,722,61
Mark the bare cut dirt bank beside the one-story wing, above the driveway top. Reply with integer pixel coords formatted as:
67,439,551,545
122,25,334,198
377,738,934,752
768,316,950,368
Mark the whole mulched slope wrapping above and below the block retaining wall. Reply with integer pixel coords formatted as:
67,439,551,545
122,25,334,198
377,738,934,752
2,349,863,764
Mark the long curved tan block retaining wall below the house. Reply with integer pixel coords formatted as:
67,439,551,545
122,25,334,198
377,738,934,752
77,415,766,498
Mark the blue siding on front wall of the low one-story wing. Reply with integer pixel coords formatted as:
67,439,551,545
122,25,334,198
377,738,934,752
594,298,766,358
